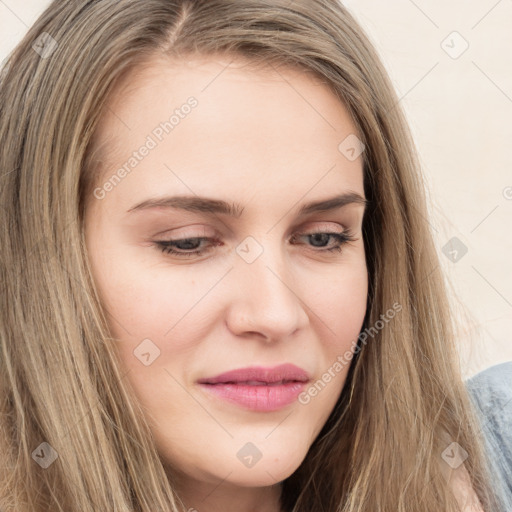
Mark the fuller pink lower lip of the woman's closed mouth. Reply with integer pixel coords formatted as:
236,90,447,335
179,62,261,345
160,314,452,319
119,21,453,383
200,382,306,412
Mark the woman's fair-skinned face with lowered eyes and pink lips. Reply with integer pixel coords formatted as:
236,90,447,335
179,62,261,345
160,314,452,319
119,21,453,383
86,53,368,506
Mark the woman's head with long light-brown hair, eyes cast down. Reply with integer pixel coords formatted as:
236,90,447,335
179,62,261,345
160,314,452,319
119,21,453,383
0,0,504,512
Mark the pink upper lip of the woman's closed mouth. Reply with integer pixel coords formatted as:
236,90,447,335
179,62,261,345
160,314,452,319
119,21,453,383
198,363,309,384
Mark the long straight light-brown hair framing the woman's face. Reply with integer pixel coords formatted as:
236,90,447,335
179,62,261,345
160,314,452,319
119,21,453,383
0,0,496,512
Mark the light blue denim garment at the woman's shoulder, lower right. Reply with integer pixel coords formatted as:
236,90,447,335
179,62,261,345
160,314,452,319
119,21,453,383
466,361,512,512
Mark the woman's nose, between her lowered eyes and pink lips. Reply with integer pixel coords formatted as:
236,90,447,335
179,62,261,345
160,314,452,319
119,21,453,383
226,241,309,342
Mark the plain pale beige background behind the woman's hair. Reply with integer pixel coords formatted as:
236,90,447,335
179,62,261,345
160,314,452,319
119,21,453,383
0,0,512,376
